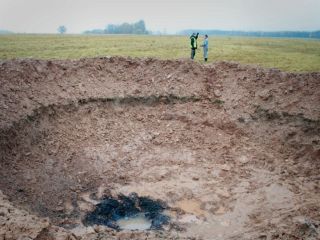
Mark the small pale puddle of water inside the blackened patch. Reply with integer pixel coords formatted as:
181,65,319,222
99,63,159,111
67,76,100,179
117,214,152,231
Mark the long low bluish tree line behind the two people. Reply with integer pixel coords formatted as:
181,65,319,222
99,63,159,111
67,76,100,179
180,29,320,38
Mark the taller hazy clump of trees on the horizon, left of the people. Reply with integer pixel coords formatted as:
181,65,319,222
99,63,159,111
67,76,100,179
84,20,149,34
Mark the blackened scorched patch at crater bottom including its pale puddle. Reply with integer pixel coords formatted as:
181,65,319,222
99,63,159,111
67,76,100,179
83,193,170,230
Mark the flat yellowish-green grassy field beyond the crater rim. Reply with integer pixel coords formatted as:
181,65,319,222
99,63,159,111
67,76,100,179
0,34,320,72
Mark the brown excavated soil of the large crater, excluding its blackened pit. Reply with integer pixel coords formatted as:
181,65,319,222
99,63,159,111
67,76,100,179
0,57,320,240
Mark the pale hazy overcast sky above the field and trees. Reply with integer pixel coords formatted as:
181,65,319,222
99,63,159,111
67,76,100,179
0,0,320,33
